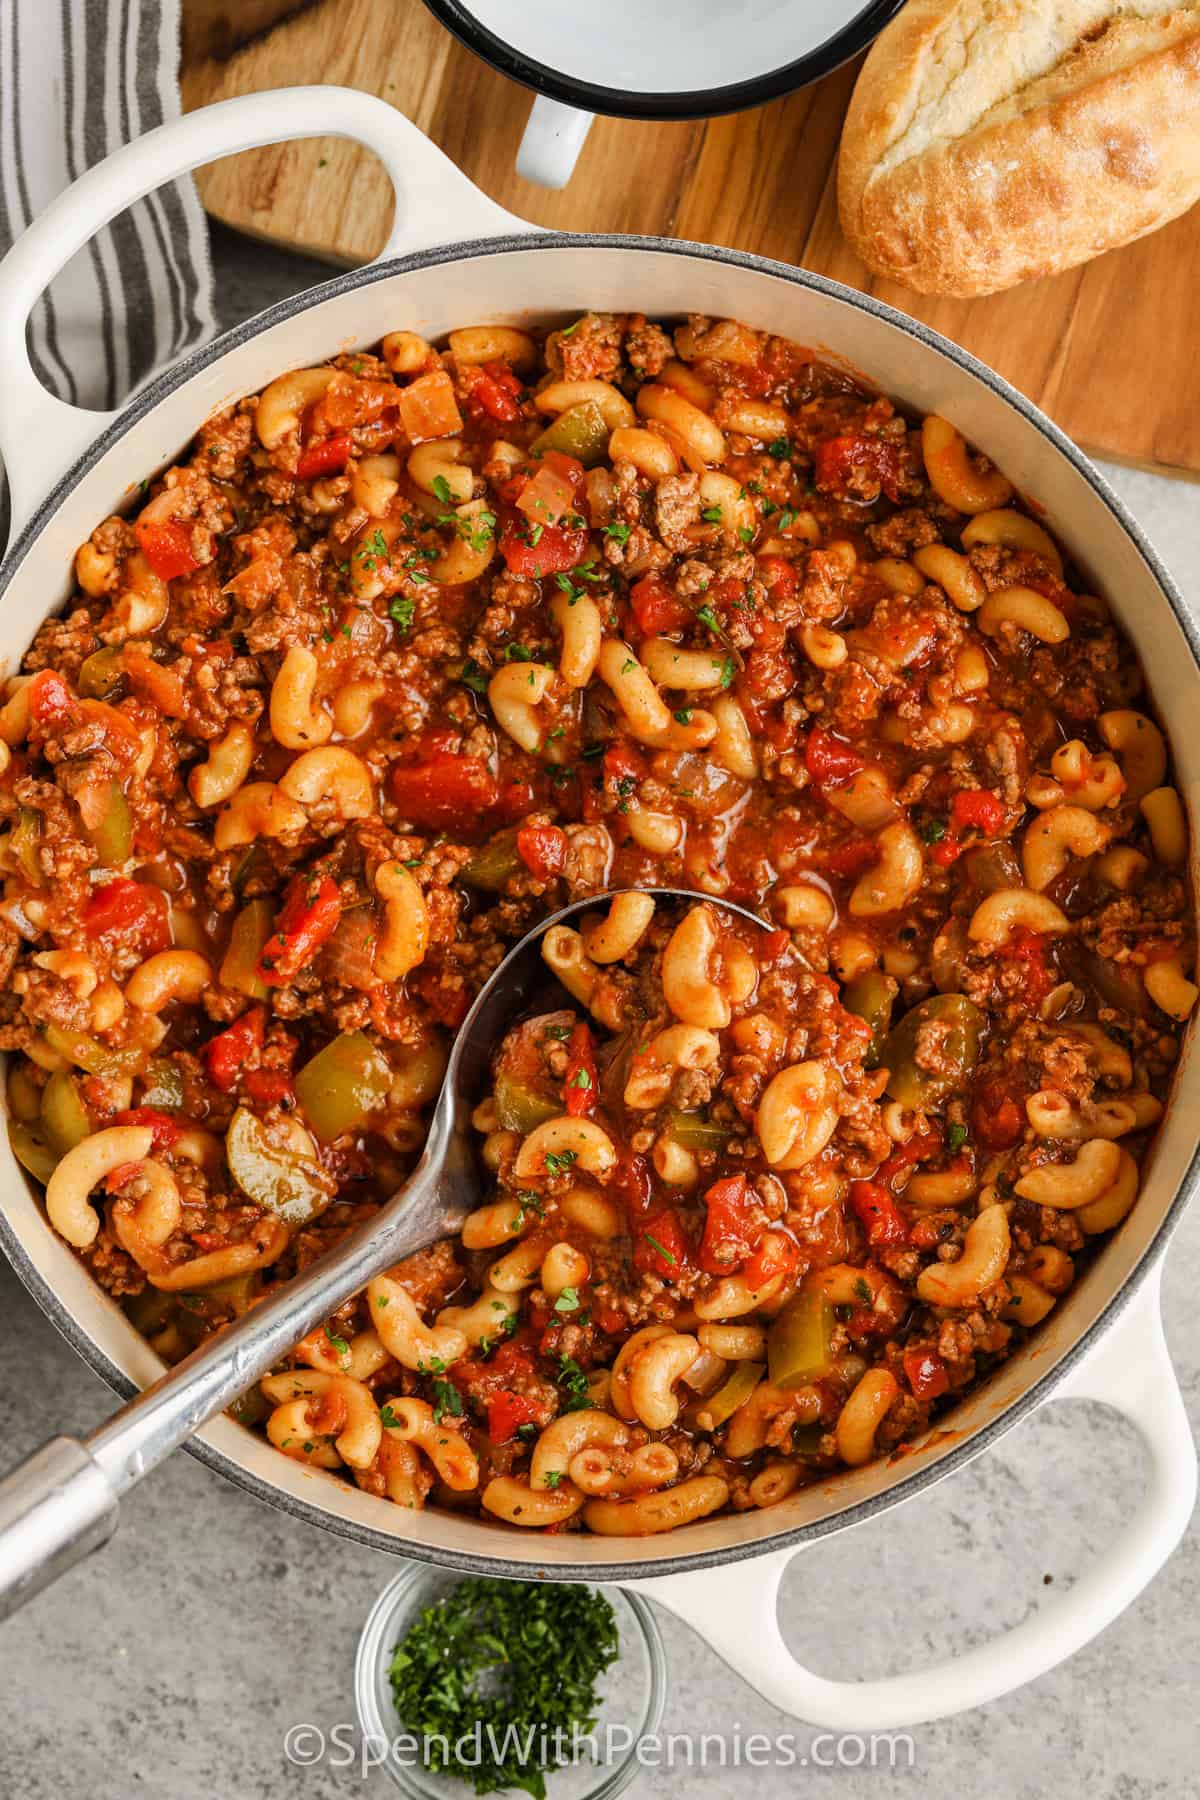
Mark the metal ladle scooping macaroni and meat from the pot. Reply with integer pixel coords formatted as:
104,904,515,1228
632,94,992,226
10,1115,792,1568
0,887,763,1618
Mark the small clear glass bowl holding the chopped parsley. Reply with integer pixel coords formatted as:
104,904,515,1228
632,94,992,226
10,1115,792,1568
354,1562,666,1800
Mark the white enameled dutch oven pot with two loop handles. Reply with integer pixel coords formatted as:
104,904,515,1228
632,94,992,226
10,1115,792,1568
0,88,1200,1730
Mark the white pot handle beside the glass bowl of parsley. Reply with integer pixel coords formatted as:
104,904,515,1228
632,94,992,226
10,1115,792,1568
637,1269,1196,1732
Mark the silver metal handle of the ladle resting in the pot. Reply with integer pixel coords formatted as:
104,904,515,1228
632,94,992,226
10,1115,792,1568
0,1144,448,1618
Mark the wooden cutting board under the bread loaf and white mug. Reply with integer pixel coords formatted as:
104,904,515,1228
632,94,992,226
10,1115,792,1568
182,0,1200,477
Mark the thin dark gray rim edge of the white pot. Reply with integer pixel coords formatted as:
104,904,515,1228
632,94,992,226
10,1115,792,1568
0,232,1200,1582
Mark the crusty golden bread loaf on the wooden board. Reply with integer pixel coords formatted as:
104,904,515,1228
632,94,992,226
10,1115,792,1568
838,0,1200,295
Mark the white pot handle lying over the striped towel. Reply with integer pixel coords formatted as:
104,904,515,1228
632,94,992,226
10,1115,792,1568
0,86,536,538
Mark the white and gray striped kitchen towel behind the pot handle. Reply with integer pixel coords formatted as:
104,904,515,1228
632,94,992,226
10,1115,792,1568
0,0,216,409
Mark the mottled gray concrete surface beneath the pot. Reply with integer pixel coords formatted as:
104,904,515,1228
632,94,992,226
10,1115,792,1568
0,236,1200,1800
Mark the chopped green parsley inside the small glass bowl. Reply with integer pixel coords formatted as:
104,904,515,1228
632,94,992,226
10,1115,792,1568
389,1576,621,1800
